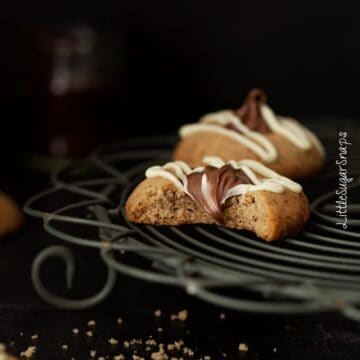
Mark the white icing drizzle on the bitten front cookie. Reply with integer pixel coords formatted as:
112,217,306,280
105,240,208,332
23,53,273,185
145,156,302,206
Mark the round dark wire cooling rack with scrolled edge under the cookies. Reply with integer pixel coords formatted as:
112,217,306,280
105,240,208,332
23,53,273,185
25,128,360,320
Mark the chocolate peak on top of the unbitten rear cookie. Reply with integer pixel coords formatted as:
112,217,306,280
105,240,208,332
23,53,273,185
226,89,271,134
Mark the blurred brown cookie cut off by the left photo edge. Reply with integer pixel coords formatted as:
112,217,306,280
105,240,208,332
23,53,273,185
0,193,24,237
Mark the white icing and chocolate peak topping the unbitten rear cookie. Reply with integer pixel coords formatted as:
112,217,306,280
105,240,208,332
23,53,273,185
180,89,325,163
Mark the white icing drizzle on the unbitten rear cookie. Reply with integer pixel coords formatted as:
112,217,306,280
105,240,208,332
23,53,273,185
179,104,325,163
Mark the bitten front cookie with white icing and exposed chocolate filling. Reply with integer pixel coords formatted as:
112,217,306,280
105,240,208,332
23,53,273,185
125,157,309,241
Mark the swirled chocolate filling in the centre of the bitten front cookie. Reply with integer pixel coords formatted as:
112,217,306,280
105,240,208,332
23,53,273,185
186,165,252,224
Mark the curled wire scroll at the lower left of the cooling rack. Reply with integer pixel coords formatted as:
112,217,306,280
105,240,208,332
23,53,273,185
31,246,117,310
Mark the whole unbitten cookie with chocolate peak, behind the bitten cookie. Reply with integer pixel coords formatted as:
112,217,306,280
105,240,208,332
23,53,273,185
173,89,325,179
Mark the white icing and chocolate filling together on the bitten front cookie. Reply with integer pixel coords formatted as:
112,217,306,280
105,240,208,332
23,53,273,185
145,157,302,224
